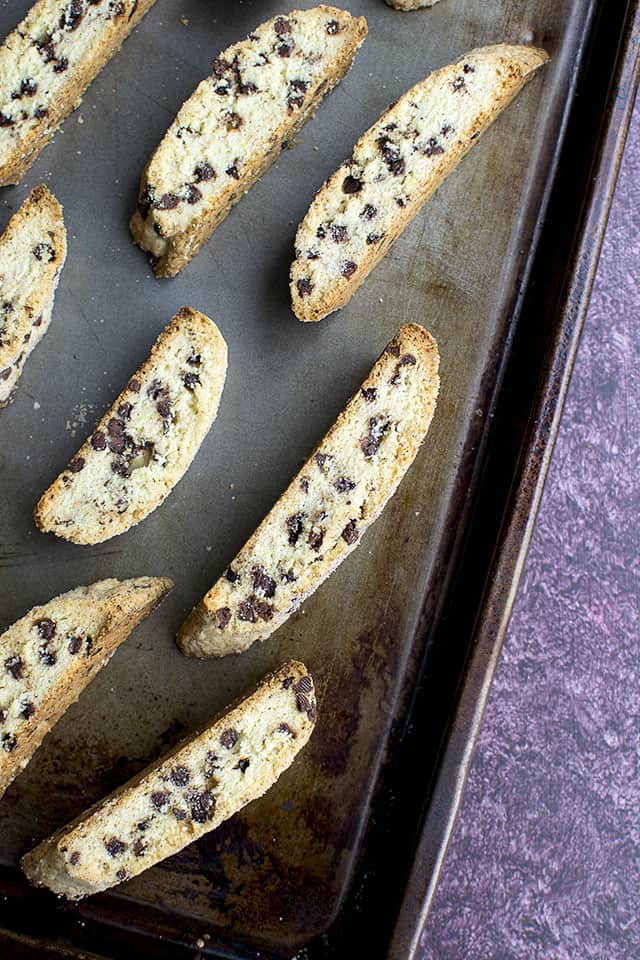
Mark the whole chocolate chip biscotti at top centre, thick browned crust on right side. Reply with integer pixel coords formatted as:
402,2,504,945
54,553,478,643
130,6,367,277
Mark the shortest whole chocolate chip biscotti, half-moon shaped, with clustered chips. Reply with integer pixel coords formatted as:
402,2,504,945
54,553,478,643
34,307,227,543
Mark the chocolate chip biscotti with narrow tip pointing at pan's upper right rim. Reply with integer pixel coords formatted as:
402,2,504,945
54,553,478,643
291,44,548,321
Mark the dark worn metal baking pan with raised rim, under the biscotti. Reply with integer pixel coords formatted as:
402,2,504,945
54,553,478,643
0,0,638,960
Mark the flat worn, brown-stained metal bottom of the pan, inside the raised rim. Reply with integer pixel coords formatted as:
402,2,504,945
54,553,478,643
0,0,632,956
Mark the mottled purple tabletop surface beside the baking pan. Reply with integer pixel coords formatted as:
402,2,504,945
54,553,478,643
422,97,640,960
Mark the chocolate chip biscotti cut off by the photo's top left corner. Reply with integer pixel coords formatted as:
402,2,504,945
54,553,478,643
0,0,155,186
